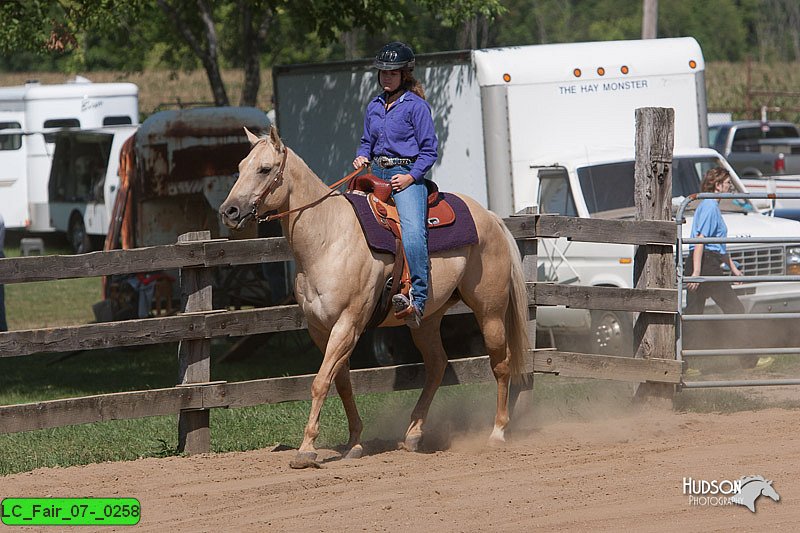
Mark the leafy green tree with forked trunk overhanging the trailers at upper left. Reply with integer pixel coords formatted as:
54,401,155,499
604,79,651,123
0,0,502,106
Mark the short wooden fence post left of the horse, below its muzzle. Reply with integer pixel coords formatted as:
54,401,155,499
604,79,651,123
178,231,213,454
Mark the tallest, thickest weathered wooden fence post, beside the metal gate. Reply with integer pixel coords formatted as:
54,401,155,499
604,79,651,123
633,107,680,407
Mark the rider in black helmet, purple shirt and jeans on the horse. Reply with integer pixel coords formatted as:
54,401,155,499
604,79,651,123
353,42,439,328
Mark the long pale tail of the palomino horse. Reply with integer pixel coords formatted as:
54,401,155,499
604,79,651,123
492,213,531,376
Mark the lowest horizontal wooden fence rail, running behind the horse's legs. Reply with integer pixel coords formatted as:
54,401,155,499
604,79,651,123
0,351,681,434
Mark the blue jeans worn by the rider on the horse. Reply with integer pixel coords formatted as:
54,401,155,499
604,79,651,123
372,164,430,313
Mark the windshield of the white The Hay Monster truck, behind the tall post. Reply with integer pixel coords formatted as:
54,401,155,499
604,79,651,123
578,157,736,214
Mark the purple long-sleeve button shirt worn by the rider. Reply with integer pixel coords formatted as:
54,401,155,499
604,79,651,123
357,91,439,181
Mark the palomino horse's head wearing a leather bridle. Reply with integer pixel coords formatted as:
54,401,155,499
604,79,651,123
219,127,288,229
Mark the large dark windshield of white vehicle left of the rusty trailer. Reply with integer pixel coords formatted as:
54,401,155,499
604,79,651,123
50,132,114,202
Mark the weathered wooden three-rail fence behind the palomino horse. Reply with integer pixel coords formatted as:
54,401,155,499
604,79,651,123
0,215,681,452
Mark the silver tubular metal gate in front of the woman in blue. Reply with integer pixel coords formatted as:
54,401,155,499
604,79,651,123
675,193,800,389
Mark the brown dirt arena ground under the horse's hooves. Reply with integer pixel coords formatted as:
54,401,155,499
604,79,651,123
0,402,800,533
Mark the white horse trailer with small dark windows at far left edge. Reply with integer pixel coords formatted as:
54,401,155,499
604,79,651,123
0,77,139,231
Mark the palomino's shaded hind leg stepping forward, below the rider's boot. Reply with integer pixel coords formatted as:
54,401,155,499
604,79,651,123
403,310,447,451
